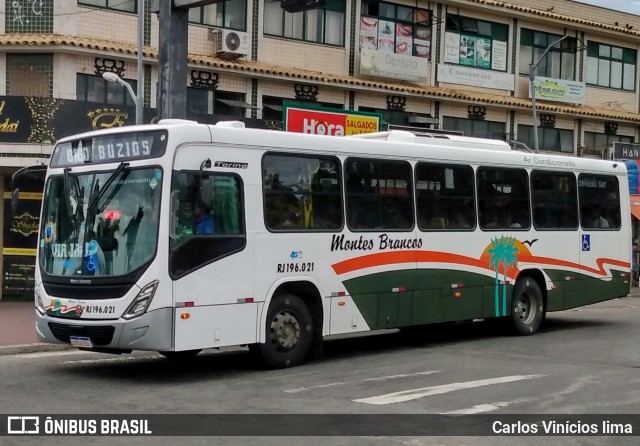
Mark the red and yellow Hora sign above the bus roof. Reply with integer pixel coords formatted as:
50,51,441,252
283,104,382,136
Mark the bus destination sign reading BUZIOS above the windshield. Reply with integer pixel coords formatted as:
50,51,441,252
51,130,167,167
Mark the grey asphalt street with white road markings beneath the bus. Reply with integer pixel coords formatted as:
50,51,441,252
0,298,640,446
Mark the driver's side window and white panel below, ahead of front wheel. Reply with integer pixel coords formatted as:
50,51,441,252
169,167,258,350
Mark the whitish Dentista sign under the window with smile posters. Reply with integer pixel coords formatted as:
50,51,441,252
360,49,429,82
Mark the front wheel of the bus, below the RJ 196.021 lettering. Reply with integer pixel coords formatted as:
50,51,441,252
250,294,313,369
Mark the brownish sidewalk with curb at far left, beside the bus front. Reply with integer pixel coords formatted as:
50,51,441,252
0,287,640,356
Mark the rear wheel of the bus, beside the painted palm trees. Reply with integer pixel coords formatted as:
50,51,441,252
511,277,544,336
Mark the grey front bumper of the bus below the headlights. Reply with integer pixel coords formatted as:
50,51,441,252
35,308,173,353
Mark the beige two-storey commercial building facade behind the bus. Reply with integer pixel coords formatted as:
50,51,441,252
0,0,640,294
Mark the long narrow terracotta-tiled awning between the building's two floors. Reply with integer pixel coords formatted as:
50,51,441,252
0,32,640,123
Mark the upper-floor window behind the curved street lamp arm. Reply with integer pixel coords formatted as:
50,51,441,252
520,28,577,80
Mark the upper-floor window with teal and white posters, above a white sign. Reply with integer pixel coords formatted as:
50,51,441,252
444,14,509,71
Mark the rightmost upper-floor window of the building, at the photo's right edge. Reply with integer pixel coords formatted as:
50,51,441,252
587,42,637,91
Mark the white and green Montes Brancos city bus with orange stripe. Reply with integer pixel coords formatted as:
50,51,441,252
22,120,631,367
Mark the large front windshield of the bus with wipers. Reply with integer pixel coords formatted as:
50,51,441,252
39,167,162,277
